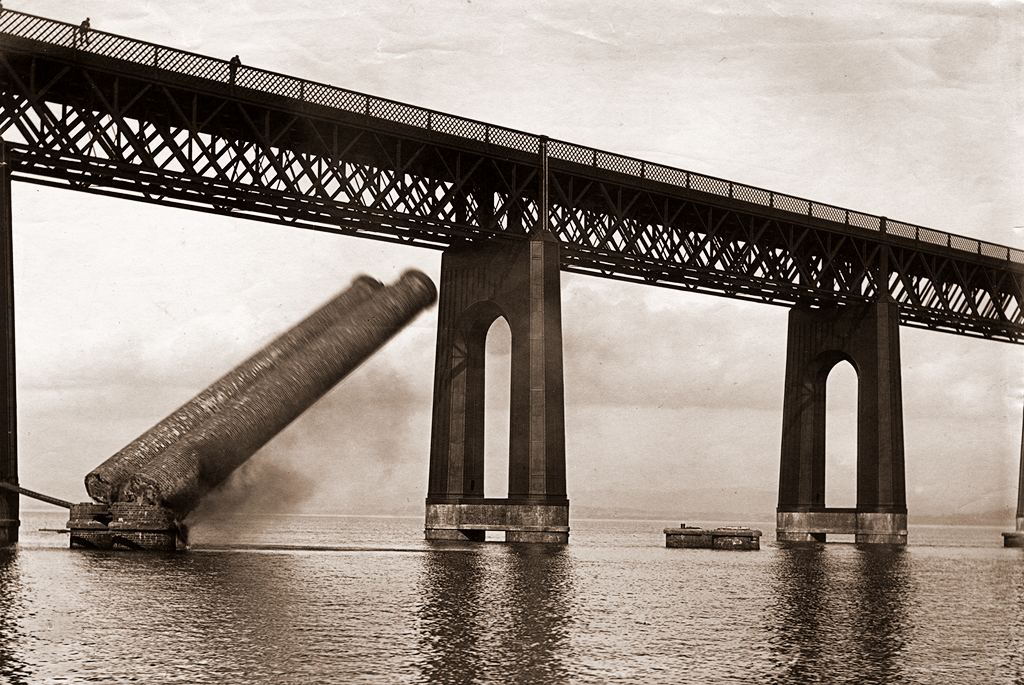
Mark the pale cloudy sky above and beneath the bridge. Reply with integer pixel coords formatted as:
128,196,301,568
5,0,1024,524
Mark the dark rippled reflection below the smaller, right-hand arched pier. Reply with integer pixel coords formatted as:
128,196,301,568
766,545,912,683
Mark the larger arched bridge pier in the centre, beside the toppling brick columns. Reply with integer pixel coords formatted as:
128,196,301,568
425,231,569,543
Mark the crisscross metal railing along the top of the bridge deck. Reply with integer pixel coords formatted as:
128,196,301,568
0,10,1024,264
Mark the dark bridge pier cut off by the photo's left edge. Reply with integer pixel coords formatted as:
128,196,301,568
0,140,19,547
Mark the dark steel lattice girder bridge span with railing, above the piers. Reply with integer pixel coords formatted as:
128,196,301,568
0,10,1024,344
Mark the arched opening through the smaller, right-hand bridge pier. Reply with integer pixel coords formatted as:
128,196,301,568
825,361,857,507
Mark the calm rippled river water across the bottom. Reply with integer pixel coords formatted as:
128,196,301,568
0,511,1024,684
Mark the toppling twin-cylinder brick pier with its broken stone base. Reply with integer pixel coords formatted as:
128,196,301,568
69,271,437,549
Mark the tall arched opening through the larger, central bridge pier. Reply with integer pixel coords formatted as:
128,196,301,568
483,316,512,499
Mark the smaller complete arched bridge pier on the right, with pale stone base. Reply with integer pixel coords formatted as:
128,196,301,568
776,299,906,545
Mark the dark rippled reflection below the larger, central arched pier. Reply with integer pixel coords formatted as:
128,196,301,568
418,544,572,684
